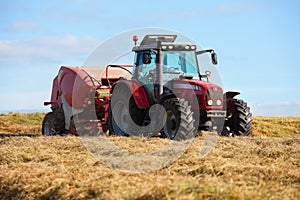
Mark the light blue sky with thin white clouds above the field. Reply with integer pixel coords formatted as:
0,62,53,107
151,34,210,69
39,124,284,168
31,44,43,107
0,0,300,116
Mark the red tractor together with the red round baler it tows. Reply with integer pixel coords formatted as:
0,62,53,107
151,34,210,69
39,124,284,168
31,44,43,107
43,35,252,140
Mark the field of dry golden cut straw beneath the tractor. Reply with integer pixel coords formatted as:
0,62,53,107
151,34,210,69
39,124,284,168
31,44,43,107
0,113,300,200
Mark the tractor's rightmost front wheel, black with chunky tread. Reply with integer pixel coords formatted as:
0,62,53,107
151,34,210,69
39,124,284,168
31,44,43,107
221,99,252,136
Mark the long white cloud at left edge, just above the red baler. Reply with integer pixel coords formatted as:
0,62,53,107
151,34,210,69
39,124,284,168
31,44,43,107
0,34,99,62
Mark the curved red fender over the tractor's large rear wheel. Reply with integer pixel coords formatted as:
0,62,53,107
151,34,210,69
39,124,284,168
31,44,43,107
111,79,150,108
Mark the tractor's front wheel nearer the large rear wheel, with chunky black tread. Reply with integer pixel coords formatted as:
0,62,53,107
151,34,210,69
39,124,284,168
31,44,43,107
162,98,196,140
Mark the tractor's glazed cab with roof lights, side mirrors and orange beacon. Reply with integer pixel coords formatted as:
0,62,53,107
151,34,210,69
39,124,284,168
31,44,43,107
132,35,217,102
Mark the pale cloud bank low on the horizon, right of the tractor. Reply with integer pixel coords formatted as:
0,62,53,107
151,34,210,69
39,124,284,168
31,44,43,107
249,101,300,117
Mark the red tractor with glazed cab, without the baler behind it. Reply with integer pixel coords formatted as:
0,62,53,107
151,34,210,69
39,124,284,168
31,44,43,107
110,35,252,139
